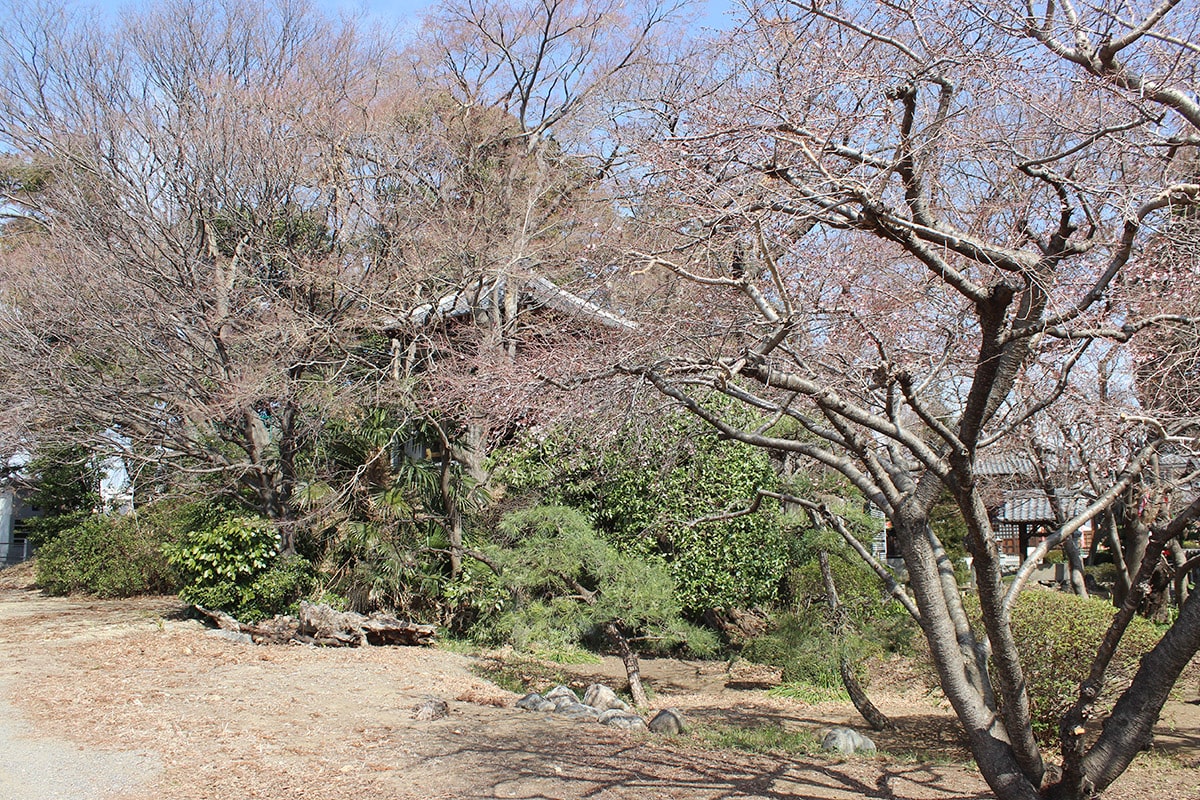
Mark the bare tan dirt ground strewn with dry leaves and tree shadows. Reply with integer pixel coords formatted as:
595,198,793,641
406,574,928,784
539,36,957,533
0,570,1200,800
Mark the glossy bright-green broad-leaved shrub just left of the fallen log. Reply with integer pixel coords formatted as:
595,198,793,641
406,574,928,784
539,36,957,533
164,516,312,621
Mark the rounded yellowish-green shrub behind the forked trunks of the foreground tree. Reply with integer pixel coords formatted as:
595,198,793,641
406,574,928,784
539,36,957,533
988,589,1160,740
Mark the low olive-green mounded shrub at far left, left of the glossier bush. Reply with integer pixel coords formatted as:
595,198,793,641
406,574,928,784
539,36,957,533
36,515,179,597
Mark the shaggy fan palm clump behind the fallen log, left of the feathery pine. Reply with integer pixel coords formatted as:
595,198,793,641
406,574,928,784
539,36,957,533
300,407,494,628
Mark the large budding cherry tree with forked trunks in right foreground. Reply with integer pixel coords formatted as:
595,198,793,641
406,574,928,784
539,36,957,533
623,1,1200,800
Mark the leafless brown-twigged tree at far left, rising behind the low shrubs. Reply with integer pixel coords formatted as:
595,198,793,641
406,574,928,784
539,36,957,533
0,0,398,547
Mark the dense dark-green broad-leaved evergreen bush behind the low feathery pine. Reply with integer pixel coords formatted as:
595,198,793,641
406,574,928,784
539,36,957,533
496,402,788,614
